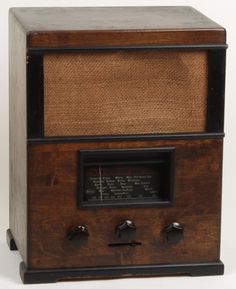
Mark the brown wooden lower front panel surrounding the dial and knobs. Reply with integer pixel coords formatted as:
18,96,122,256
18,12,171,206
28,139,222,268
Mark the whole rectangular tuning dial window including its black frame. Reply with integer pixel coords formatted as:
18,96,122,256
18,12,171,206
78,149,173,207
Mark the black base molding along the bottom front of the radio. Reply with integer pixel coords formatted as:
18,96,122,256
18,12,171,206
20,261,224,284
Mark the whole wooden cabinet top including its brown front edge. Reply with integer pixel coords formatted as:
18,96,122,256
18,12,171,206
10,6,225,48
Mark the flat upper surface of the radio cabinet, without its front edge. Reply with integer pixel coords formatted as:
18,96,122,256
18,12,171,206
10,6,222,31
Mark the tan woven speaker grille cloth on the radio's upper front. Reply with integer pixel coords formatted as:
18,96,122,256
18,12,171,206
44,49,208,136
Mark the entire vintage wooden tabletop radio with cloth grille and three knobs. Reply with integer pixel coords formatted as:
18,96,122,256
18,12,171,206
7,7,227,283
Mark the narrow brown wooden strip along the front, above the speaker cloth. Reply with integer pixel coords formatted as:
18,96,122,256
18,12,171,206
28,29,225,48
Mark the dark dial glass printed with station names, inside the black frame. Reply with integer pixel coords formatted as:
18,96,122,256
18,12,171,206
84,164,160,202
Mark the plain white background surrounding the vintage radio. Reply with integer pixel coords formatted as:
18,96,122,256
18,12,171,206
0,0,236,289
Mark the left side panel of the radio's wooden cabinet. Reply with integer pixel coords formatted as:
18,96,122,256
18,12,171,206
9,12,27,263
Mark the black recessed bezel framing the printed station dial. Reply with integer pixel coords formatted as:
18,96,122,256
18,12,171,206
77,147,175,208
